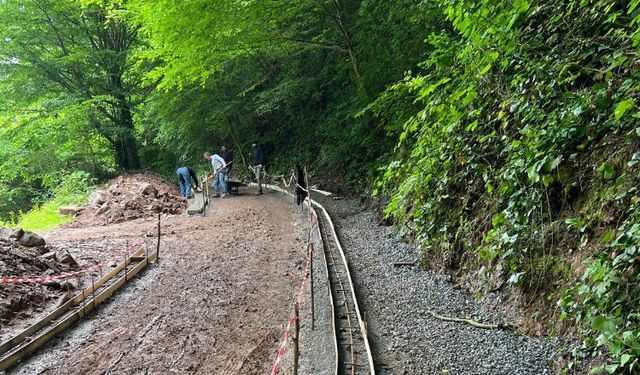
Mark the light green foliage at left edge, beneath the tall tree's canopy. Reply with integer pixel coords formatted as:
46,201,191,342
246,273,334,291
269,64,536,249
0,98,115,221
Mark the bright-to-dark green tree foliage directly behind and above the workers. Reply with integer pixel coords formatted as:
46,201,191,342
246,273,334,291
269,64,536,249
128,0,444,189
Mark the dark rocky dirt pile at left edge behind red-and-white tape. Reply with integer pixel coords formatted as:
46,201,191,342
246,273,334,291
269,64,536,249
0,228,78,327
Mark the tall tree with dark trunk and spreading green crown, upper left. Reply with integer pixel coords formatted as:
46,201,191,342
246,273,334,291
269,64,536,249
0,0,151,169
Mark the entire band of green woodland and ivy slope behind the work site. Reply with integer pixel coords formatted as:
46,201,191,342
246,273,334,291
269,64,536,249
0,0,640,373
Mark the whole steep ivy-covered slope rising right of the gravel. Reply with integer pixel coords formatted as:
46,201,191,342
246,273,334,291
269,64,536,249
375,0,640,373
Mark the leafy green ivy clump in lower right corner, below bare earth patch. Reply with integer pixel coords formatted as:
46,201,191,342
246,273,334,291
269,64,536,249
559,204,640,373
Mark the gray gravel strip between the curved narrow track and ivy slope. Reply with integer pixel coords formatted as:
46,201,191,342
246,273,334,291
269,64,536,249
322,200,553,375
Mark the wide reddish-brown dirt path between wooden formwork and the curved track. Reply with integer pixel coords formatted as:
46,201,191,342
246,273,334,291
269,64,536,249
10,194,306,375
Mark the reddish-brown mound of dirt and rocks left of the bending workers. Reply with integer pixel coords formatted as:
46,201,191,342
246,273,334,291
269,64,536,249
69,173,187,227
